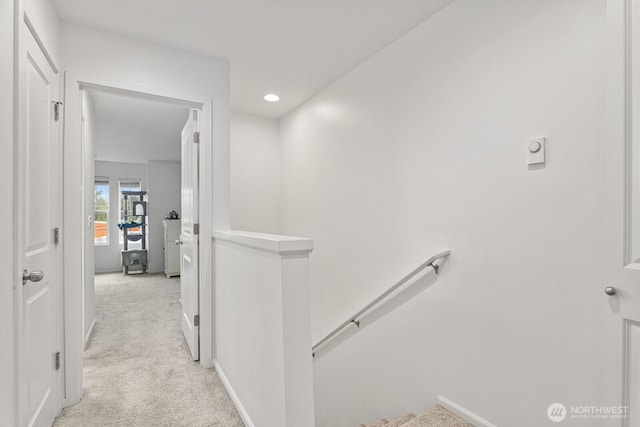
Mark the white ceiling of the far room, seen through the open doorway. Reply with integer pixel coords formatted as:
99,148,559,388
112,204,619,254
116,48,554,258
89,92,189,163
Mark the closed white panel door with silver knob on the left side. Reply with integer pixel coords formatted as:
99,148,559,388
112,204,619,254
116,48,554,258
15,16,61,426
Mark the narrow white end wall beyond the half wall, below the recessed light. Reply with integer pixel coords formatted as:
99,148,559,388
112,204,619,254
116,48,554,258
231,113,280,234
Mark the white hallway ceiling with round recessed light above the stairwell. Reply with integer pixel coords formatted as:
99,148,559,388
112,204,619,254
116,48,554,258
54,0,453,118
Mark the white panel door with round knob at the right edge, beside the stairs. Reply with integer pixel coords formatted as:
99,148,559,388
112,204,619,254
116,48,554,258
602,0,640,427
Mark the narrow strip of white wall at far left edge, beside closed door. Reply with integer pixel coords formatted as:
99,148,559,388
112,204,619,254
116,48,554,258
0,0,18,425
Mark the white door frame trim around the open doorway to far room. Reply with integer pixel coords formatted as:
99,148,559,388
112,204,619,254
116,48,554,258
63,79,214,406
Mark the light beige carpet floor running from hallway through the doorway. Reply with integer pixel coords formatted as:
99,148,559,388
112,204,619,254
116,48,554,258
54,274,244,427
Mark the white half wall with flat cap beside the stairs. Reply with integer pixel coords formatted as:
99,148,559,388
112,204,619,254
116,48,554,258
214,231,314,427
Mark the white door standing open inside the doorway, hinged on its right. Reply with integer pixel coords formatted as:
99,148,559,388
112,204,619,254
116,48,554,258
180,110,200,360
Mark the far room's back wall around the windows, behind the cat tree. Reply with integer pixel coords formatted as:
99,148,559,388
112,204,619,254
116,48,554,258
91,161,148,273
